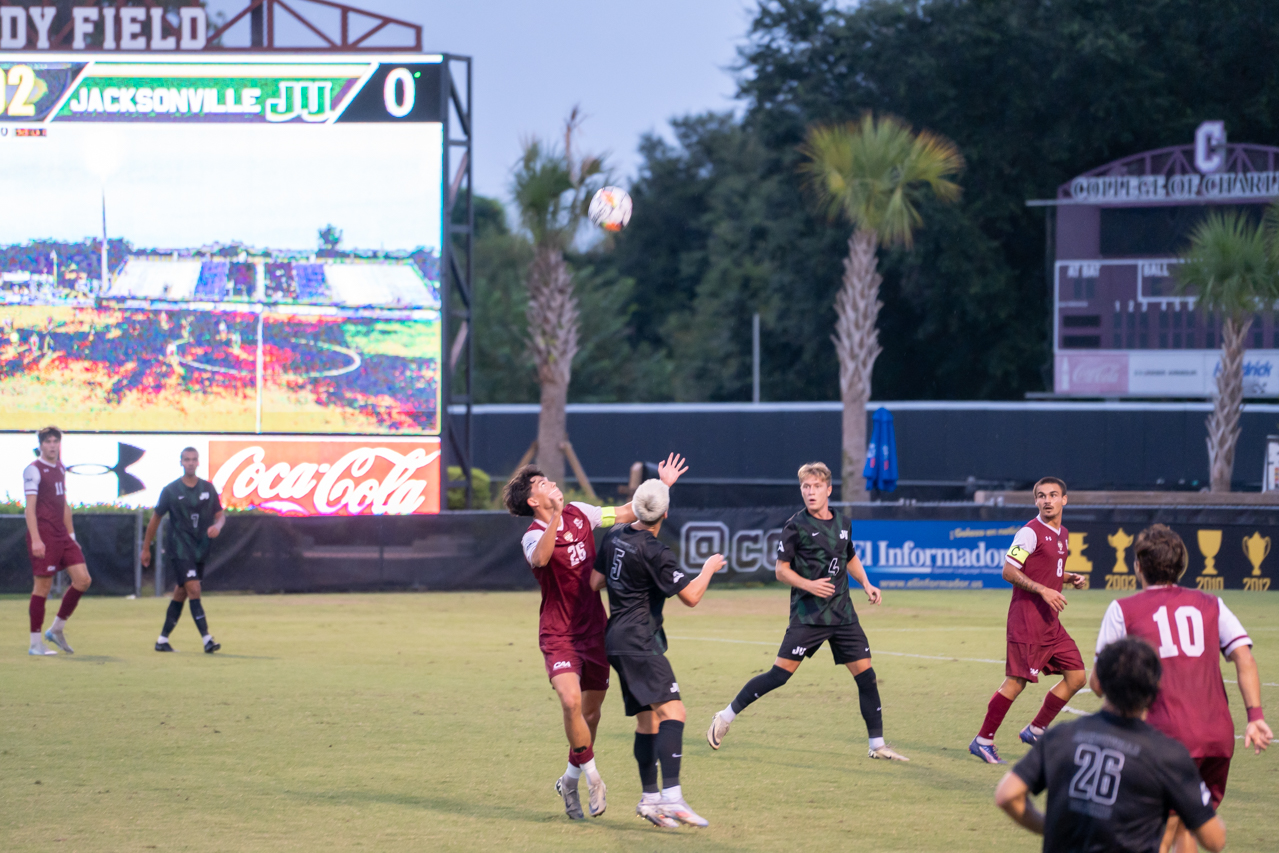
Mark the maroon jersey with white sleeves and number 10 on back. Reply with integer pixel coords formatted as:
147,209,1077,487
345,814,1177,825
1097,586,1252,758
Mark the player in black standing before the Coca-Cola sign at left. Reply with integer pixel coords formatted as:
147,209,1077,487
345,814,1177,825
142,448,226,655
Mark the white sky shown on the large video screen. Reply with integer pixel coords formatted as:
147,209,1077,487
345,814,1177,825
0,121,440,249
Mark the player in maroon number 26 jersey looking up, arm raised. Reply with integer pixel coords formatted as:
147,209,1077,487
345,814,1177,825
503,453,688,820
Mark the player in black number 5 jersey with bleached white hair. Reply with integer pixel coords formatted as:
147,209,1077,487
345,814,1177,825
591,480,724,827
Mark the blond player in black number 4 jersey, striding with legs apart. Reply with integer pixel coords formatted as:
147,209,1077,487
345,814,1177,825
706,462,909,761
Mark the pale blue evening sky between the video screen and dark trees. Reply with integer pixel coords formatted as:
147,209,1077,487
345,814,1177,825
208,0,756,201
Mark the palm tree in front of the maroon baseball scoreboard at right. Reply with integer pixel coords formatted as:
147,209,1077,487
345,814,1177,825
1177,211,1279,491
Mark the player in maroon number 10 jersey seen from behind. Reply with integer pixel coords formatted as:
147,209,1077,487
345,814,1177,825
1091,524,1274,853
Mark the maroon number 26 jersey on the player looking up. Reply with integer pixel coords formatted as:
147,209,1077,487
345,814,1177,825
523,503,608,648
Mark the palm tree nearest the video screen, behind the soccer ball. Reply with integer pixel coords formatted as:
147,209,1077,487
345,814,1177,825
513,107,604,481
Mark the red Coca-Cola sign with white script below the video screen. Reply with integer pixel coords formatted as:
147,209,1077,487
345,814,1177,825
208,439,440,515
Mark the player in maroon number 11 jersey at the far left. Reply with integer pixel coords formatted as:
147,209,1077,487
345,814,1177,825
22,427,92,655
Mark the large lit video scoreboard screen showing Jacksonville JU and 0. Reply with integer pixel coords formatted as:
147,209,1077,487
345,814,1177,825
0,52,444,436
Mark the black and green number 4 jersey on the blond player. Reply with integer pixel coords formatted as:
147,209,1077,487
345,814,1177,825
778,509,857,625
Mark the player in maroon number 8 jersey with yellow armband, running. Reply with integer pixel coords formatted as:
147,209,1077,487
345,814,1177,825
968,477,1087,765
